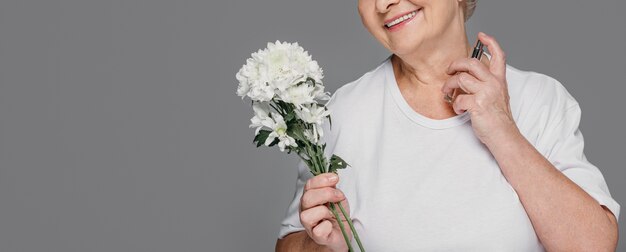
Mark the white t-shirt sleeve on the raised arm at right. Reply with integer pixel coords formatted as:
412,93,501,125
544,99,620,219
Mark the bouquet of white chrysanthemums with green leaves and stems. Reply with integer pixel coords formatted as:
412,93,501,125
236,41,364,251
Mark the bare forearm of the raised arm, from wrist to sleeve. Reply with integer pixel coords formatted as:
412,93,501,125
487,128,618,251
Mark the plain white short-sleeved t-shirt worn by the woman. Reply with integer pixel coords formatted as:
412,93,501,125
278,55,620,252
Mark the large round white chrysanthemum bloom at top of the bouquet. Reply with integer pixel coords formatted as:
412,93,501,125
236,41,323,101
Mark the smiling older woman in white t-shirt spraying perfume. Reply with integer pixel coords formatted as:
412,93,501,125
277,0,620,251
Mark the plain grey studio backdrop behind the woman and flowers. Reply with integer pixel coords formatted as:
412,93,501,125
0,0,626,252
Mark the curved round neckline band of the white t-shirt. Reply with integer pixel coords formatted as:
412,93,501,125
385,53,491,129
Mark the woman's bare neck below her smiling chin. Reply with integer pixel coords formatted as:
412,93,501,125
391,25,473,89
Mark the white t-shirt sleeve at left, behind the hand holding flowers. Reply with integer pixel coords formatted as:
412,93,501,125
278,160,313,239
